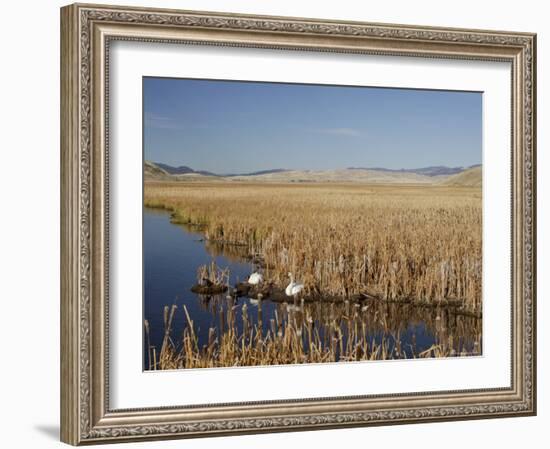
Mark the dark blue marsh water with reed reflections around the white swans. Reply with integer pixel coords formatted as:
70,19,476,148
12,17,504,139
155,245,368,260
143,208,481,369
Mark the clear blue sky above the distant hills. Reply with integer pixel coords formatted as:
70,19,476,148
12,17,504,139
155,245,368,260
143,77,482,174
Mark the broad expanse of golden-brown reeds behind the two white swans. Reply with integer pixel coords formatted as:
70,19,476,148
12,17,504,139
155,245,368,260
144,181,482,312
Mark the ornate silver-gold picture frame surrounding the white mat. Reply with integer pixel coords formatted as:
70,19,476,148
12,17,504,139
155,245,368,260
61,4,536,445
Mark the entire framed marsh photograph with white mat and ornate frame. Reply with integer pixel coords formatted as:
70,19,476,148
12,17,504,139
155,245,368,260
61,4,536,445
